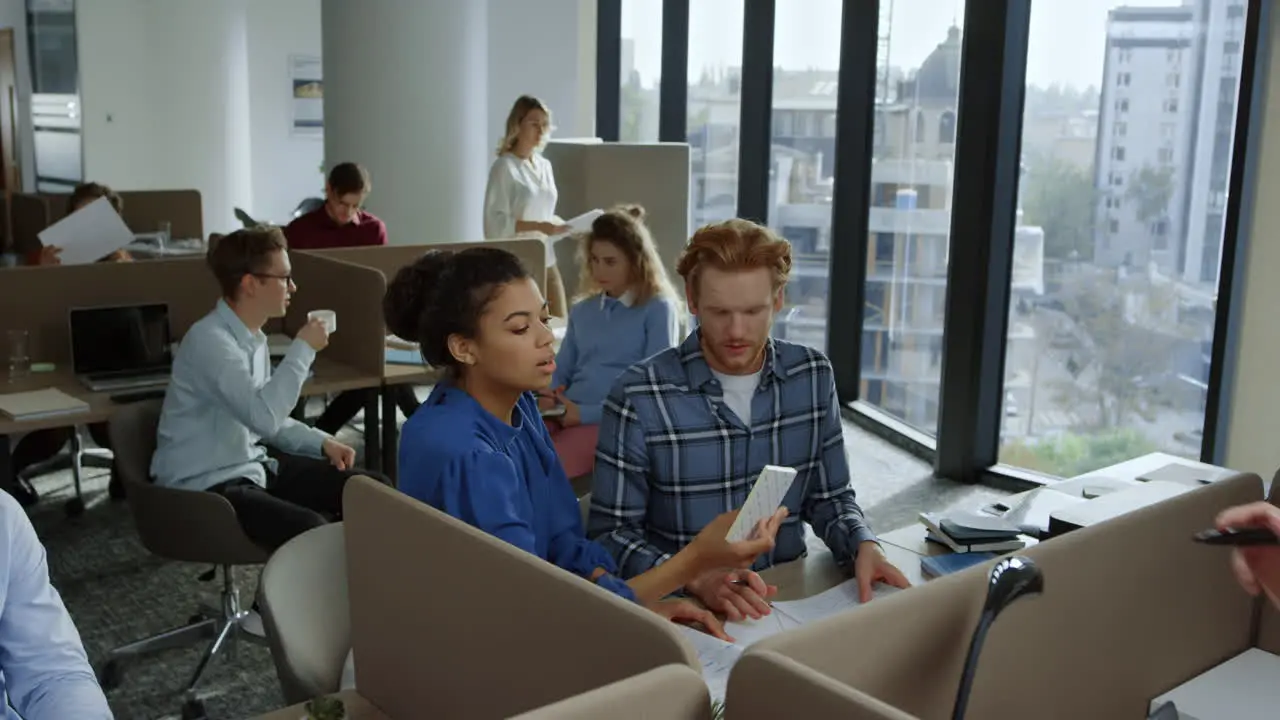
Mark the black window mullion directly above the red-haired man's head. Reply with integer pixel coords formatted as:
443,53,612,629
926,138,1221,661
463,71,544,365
737,0,776,223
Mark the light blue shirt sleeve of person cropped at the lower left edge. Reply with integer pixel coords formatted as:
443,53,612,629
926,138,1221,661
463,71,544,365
0,484,111,720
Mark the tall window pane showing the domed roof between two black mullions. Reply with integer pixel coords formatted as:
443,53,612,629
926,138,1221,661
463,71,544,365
849,0,960,434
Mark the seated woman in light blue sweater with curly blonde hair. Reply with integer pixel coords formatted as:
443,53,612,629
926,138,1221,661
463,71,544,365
539,205,682,478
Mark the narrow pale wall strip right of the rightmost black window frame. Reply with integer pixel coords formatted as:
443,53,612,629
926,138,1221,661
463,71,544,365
1225,10,1280,478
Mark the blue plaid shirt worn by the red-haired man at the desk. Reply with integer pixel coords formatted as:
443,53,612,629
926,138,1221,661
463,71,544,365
588,331,876,578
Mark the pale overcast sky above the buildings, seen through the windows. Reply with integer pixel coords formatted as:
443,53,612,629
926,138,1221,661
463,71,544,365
622,0,1179,88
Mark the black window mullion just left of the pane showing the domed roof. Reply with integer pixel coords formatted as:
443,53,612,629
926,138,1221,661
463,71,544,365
827,0,879,402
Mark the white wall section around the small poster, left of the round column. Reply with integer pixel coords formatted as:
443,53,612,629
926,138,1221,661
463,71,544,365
246,0,322,223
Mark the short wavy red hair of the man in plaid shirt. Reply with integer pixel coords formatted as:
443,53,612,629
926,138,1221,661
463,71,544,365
676,218,791,300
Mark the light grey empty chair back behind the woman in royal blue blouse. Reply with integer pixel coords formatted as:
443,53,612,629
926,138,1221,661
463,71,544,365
259,523,351,705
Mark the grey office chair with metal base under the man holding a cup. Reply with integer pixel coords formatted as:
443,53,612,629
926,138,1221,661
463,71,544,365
97,401,269,720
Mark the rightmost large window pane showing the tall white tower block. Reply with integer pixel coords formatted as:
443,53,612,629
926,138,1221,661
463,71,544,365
1000,0,1245,477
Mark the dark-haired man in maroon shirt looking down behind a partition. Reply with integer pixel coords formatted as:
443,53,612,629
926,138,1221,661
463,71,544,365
284,163,419,434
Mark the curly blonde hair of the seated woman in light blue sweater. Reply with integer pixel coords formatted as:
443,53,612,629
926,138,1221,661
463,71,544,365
577,205,682,307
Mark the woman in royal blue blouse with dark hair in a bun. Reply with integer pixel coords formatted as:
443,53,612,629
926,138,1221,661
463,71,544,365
384,247,786,637
